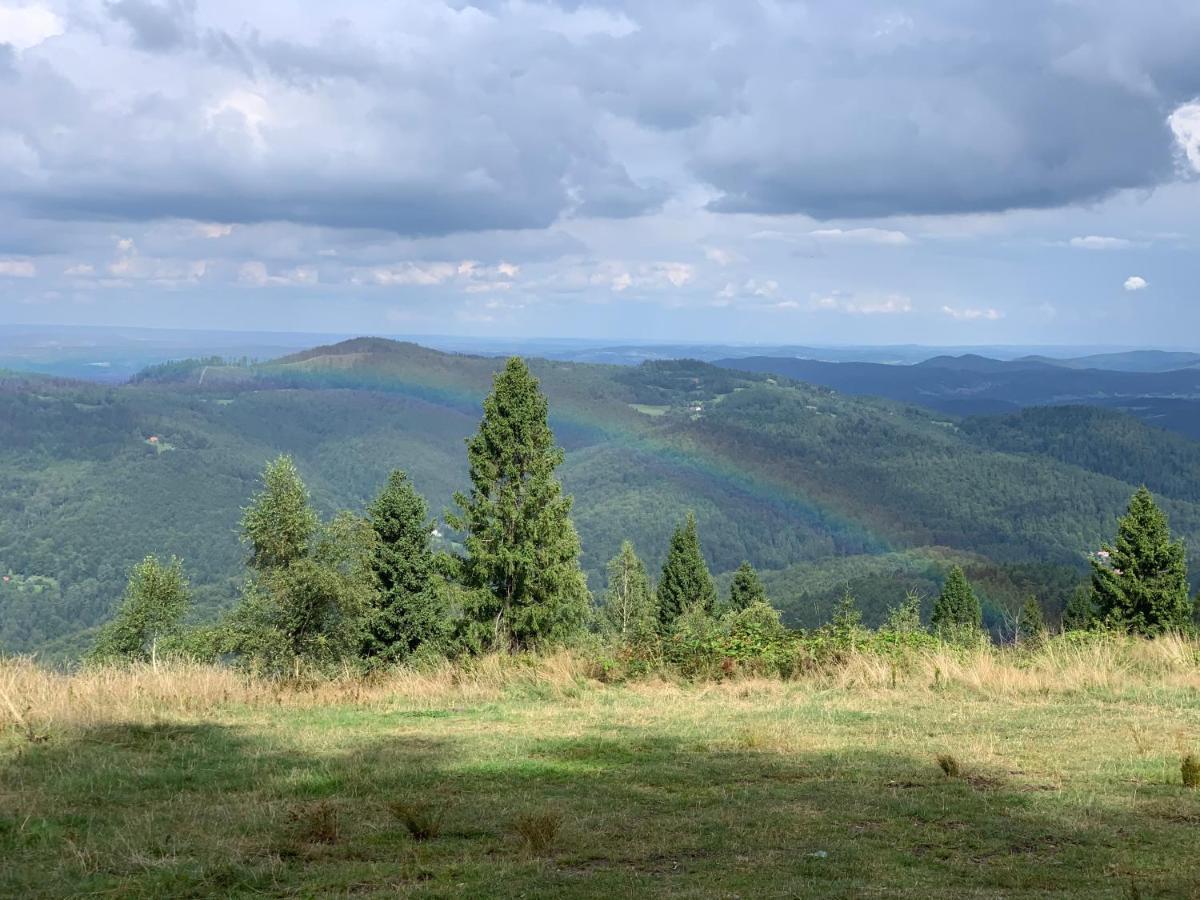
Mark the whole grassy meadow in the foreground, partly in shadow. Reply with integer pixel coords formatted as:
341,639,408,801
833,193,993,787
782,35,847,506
0,638,1200,900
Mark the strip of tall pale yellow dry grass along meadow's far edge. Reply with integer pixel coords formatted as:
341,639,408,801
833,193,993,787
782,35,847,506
0,636,1200,734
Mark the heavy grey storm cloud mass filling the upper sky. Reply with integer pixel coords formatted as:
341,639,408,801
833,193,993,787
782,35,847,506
0,0,1200,235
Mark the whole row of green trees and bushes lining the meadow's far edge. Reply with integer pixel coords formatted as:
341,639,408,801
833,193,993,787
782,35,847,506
91,358,1195,677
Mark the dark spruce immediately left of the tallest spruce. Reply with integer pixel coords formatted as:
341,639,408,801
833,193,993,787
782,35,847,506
362,469,449,661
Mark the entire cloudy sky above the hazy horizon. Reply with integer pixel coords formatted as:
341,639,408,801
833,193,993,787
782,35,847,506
0,0,1200,347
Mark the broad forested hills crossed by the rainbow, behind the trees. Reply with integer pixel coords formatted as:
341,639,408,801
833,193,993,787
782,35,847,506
0,338,1200,653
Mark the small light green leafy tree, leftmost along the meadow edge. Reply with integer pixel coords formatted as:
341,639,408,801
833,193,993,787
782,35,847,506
90,556,191,662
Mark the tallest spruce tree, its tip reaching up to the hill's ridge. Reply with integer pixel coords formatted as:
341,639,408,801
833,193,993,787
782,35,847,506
448,356,589,649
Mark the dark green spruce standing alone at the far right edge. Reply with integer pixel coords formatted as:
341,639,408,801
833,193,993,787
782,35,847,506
1092,486,1192,635
